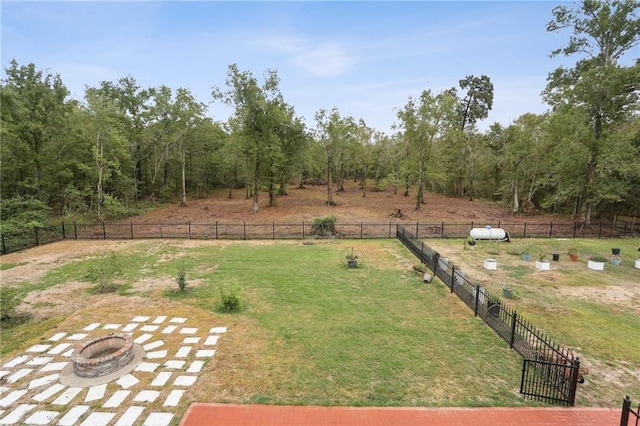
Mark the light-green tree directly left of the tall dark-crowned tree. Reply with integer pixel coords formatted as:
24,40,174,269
397,90,456,210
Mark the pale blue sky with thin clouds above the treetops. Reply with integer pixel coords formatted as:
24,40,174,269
0,0,592,134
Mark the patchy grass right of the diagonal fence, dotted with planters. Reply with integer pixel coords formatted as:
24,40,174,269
425,239,640,406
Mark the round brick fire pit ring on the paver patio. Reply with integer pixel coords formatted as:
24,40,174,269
71,333,134,378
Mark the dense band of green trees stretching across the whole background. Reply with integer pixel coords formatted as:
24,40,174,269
0,0,640,232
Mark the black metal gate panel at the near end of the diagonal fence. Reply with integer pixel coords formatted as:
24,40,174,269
520,359,580,406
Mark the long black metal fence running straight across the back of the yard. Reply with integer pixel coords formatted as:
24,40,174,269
0,220,640,254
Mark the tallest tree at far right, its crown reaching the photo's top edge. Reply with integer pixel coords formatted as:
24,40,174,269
544,0,640,226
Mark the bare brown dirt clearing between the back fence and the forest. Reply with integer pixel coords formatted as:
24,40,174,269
133,182,567,224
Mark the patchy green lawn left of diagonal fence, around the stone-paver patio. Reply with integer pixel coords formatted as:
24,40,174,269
0,240,536,406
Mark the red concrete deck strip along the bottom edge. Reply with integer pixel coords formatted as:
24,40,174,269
180,403,621,426
